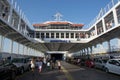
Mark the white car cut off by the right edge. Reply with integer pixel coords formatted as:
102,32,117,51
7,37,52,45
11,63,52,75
105,58,120,75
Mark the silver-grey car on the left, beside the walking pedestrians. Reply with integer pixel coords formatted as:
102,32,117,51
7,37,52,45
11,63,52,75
12,58,30,74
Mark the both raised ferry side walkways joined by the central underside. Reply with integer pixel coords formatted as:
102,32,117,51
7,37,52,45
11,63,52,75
0,0,120,56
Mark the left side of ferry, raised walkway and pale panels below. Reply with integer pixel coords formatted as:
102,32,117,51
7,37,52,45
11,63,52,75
0,0,44,56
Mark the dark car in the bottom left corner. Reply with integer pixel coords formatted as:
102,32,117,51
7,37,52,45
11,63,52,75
0,61,17,80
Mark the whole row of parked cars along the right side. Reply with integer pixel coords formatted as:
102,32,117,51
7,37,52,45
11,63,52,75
66,56,120,75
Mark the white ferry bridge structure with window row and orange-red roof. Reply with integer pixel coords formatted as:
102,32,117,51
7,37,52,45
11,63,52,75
33,21,86,43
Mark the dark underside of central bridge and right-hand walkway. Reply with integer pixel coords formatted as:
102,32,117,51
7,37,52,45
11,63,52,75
41,27,120,52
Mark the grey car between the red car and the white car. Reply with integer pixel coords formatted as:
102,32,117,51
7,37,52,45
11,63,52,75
94,59,107,70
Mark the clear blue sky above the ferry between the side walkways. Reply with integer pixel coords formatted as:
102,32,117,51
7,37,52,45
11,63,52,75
16,0,111,28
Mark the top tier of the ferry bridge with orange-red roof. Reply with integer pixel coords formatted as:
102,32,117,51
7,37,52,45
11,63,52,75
33,21,84,30
